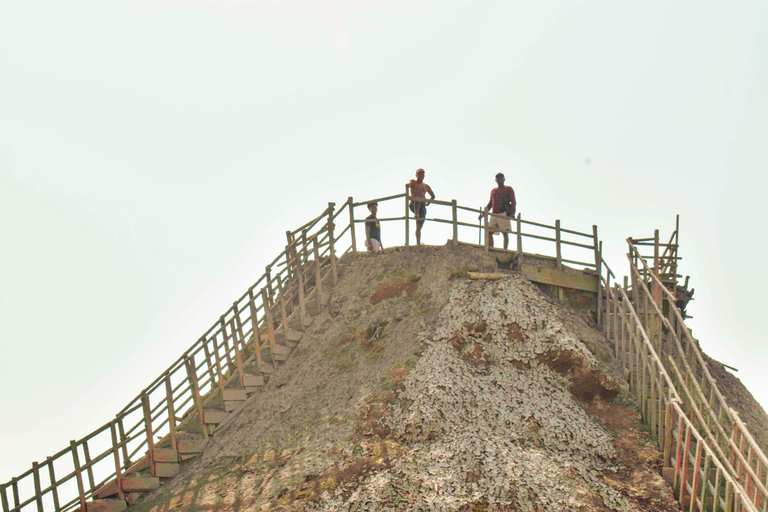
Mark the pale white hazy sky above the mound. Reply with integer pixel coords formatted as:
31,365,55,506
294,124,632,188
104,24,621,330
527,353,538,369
0,0,768,482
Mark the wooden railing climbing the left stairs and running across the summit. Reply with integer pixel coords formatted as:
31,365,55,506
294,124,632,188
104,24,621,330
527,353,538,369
0,190,668,512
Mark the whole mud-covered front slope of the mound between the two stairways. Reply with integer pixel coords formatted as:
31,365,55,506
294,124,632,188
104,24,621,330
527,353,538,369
132,247,679,512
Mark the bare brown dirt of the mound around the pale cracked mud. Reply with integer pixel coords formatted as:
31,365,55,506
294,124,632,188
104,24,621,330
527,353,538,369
131,247,768,512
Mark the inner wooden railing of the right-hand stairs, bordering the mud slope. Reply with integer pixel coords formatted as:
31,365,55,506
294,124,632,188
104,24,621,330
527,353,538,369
601,262,764,512
